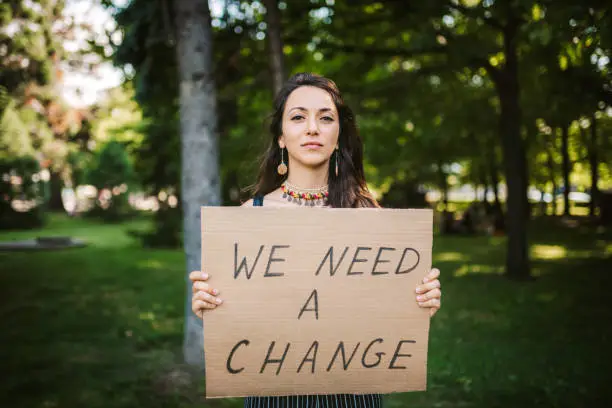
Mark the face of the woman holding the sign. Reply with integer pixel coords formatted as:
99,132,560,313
278,86,340,168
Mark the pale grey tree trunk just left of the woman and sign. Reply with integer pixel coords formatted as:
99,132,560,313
175,0,221,366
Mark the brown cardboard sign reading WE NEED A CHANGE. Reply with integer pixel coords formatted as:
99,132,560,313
202,207,433,398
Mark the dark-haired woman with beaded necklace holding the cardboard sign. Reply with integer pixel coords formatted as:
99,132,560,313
190,73,441,407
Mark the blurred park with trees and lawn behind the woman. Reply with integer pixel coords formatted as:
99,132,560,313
0,0,612,408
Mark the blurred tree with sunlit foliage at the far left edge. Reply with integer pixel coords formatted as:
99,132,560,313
0,0,95,211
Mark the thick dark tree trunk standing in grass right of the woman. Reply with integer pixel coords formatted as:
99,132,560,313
489,18,531,279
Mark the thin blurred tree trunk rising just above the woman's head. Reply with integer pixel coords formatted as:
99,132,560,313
264,0,285,95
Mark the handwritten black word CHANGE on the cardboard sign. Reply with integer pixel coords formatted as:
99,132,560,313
226,338,416,375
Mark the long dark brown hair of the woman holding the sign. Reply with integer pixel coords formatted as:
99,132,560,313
254,73,379,208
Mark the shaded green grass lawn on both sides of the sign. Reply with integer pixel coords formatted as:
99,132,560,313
0,216,612,408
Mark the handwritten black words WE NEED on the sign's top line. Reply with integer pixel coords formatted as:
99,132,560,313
234,243,421,279
